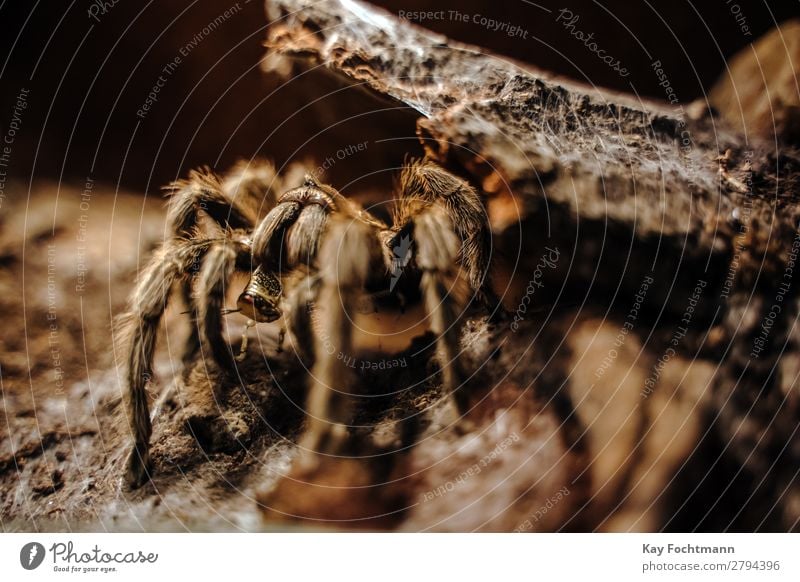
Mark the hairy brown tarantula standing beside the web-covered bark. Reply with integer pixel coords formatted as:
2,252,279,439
120,160,496,487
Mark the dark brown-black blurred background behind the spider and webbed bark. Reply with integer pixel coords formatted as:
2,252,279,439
0,0,800,192
